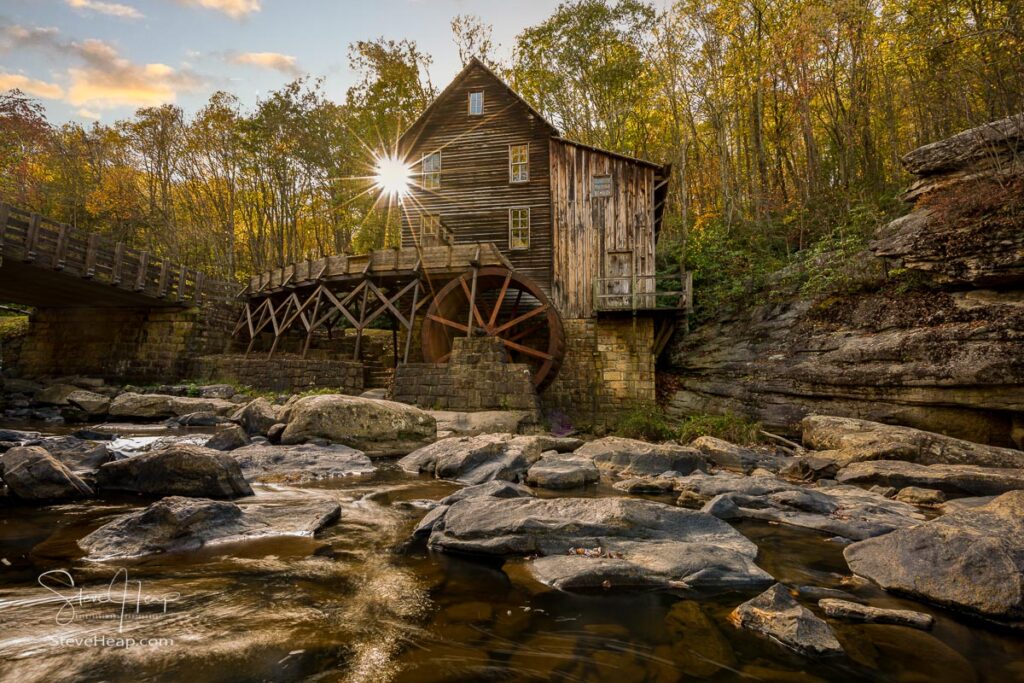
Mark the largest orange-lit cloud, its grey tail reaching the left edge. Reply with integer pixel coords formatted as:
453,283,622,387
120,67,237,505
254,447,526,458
4,25,203,110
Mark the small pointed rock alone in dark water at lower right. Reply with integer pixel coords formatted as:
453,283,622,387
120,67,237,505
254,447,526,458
729,584,843,656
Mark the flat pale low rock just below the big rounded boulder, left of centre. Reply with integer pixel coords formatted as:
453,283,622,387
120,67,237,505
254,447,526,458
230,443,377,483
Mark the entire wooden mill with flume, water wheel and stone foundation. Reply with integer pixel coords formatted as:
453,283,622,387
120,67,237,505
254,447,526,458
240,59,690,417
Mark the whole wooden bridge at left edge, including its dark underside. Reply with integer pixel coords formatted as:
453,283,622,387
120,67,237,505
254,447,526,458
0,204,237,308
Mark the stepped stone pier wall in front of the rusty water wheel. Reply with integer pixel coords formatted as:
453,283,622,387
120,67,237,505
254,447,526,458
392,337,538,411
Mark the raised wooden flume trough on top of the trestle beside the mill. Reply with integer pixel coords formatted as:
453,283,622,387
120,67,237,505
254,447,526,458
247,242,512,298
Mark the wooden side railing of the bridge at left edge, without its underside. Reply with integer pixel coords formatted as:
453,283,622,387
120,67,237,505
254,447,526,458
0,203,237,305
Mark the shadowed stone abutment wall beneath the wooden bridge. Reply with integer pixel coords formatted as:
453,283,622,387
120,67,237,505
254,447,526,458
14,303,237,382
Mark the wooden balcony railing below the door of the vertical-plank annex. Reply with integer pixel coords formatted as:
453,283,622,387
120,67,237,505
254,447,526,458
594,271,693,313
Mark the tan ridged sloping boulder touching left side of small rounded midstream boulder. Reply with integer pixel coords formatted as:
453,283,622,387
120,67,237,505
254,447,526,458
398,434,557,484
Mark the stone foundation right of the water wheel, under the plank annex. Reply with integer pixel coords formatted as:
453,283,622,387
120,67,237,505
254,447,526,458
542,317,654,425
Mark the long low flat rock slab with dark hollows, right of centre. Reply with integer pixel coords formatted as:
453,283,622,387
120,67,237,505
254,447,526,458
677,473,924,541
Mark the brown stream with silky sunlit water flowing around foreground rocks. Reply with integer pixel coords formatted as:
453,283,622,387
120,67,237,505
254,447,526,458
0,423,1024,683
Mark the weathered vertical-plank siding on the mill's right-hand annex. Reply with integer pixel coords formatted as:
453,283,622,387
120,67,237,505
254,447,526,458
550,140,654,318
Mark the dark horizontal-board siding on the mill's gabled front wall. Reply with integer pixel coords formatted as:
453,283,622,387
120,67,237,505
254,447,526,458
401,61,552,293
